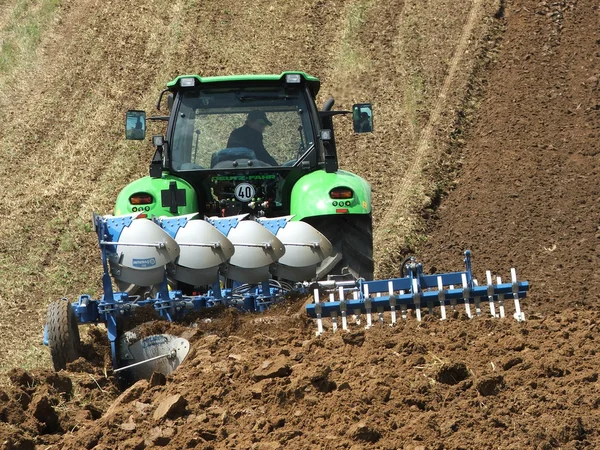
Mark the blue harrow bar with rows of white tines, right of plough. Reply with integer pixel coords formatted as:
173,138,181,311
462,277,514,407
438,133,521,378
306,250,529,334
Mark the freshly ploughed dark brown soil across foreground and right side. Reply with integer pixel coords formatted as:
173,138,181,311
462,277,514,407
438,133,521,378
0,0,600,450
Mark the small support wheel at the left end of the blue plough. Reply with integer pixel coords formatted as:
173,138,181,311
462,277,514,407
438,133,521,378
46,300,80,371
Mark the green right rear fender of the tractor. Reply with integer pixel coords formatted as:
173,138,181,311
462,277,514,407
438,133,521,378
290,170,371,220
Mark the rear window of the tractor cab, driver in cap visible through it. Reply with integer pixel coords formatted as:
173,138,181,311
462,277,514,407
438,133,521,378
167,78,322,171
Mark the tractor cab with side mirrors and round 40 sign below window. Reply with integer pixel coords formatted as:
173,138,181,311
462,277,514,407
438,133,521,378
126,72,372,222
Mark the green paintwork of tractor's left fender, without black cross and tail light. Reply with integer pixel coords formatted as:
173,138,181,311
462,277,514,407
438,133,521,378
115,172,198,218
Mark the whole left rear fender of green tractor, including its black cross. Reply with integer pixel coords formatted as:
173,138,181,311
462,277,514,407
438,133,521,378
115,173,198,219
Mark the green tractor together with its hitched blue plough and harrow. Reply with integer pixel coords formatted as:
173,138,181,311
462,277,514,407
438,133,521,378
44,72,528,380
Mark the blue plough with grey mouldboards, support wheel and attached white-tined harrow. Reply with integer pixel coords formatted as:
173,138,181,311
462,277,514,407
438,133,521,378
44,215,529,379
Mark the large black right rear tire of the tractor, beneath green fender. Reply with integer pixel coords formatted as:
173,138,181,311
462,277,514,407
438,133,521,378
306,214,374,280
